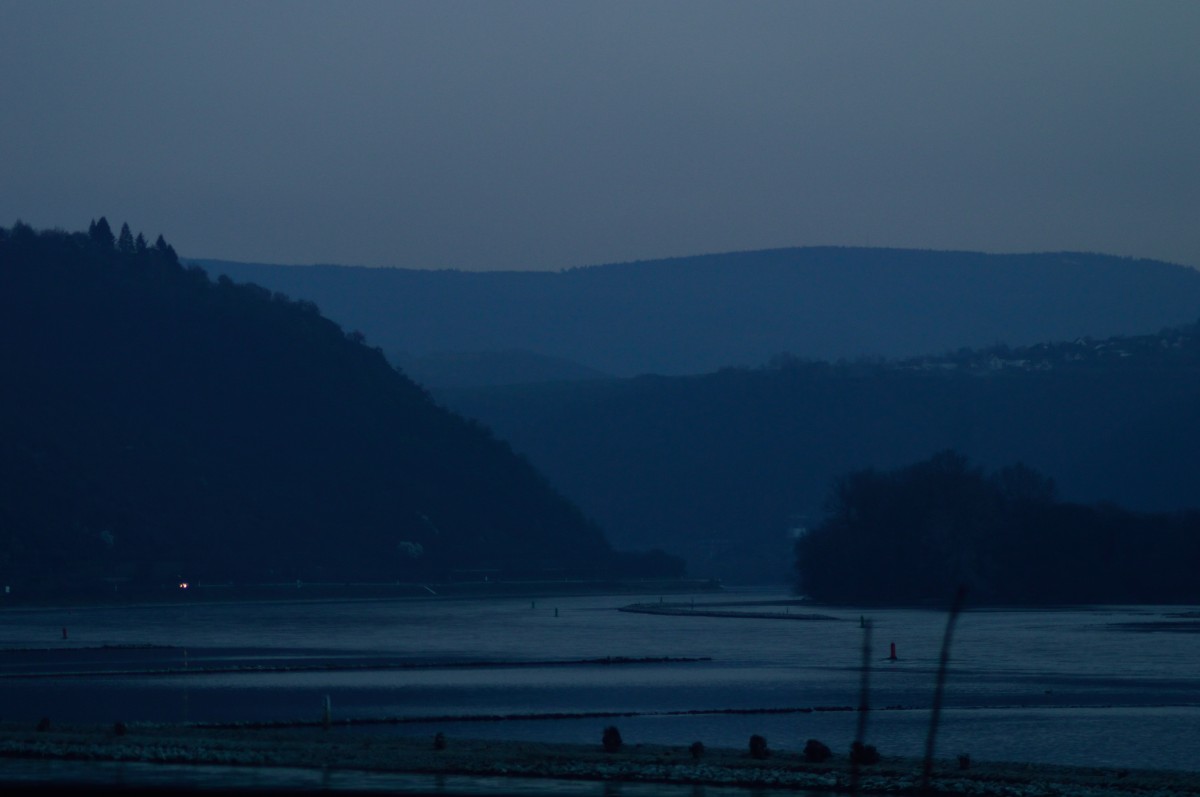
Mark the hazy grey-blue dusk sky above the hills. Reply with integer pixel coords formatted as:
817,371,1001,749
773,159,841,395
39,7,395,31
0,0,1200,269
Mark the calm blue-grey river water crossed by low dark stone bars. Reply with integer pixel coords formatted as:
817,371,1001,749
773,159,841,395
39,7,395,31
0,592,1200,787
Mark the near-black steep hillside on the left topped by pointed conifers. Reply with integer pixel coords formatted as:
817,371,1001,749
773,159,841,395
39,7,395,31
0,220,671,594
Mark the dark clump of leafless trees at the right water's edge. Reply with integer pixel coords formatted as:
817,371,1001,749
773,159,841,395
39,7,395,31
796,451,1200,604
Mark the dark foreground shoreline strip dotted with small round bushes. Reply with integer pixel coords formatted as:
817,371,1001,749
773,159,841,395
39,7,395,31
0,723,1200,797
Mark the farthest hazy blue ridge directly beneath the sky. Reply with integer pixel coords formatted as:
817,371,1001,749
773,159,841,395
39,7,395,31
199,247,1200,386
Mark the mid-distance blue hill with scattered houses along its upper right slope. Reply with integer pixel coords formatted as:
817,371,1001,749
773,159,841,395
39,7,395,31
437,325,1200,581
